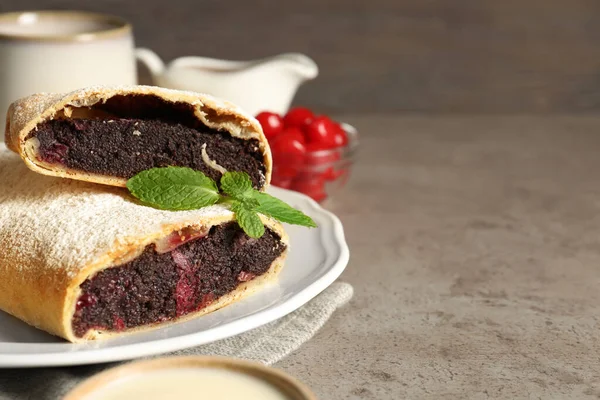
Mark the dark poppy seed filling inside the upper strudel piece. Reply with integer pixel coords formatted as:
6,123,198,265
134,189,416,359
28,96,265,188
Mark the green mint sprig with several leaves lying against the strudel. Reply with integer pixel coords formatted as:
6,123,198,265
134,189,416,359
127,167,317,238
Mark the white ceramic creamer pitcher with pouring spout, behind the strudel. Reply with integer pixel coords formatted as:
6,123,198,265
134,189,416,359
136,49,319,115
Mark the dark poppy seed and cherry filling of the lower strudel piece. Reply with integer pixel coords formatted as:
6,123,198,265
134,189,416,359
72,223,285,337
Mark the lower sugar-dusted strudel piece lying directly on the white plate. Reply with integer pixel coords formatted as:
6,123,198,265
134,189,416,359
0,144,288,342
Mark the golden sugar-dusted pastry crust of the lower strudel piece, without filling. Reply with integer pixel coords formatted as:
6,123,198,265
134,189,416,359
0,144,289,342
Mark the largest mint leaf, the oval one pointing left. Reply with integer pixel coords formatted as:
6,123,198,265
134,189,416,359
127,167,220,211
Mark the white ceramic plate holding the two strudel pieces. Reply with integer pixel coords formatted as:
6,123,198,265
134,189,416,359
0,188,349,368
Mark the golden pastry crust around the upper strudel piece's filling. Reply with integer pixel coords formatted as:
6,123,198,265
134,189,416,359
5,85,272,190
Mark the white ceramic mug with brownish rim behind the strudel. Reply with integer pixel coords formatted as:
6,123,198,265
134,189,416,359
0,11,137,141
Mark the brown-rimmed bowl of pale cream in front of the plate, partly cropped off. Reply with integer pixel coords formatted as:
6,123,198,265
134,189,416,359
65,357,316,400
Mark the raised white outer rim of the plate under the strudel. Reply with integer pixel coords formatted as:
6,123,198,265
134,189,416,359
0,186,350,369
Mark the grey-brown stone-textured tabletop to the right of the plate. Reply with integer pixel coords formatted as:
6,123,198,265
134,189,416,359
277,116,600,400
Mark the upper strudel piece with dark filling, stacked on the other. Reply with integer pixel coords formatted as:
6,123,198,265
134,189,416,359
6,86,271,190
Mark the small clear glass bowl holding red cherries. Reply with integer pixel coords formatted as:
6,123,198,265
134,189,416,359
271,123,358,203
